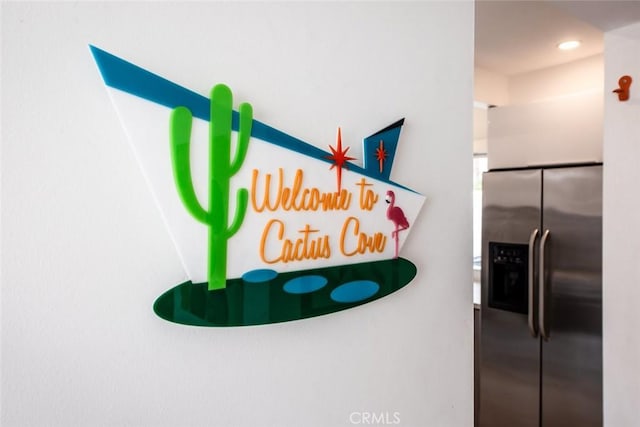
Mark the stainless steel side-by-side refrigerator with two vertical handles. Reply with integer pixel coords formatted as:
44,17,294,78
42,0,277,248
478,165,604,427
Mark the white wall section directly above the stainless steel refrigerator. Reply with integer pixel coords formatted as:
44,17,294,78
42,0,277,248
484,55,604,168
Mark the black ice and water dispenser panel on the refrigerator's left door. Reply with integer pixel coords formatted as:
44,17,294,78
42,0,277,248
489,242,529,314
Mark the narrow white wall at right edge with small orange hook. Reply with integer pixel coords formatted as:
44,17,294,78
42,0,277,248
603,23,640,427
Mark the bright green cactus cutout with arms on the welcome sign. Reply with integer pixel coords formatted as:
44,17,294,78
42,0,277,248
171,84,253,290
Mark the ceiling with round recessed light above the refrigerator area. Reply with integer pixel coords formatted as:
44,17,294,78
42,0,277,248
475,0,640,76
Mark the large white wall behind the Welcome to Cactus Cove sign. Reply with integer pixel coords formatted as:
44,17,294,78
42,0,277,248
0,2,473,427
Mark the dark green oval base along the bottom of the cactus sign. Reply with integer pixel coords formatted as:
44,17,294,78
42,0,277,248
153,258,417,327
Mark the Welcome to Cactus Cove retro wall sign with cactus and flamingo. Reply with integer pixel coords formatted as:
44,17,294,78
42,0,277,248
91,46,425,326
